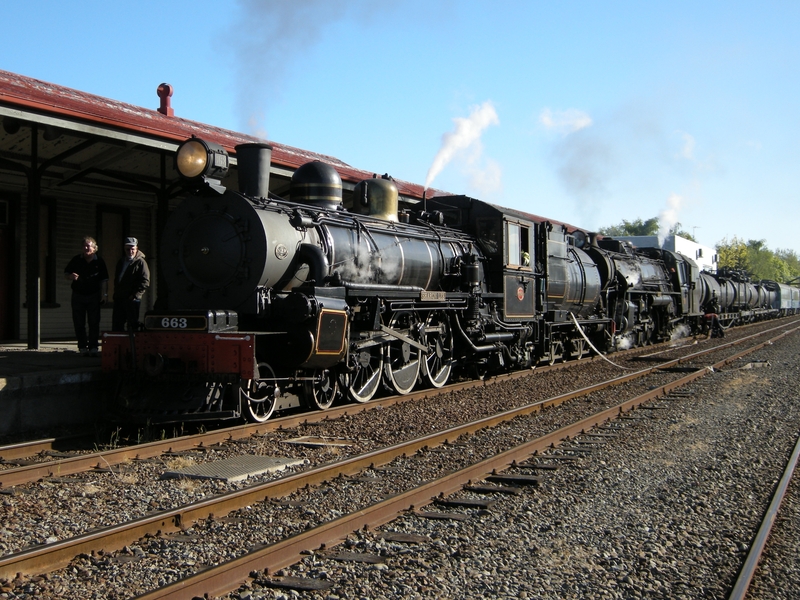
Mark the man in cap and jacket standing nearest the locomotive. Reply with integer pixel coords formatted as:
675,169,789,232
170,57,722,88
111,237,150,331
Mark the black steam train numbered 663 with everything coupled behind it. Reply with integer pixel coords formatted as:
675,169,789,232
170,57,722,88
102,138,800,422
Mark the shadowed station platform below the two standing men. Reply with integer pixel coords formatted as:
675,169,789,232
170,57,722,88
0,340,104,436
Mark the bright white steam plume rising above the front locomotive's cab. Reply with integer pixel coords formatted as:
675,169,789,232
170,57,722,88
425,100,500,191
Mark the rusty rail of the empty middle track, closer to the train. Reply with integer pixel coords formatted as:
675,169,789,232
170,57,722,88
0,327,800,579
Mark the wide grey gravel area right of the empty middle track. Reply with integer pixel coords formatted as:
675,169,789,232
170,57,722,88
236,334,800,600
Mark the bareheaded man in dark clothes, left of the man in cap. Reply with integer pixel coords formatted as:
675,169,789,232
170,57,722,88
64,236,108,356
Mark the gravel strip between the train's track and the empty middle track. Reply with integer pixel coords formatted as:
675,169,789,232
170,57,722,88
0,346,692,554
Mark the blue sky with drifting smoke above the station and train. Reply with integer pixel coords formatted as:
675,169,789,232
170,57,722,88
0,0,800,254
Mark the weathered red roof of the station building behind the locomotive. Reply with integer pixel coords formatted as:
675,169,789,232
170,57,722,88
0,70,432,198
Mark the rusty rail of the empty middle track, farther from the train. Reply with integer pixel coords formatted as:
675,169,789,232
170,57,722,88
137,322,797,600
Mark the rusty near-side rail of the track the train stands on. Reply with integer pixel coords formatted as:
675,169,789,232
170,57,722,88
0,322,793,488
